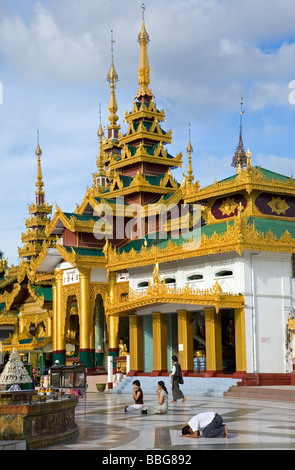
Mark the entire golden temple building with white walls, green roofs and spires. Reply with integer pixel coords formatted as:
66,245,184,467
0,7,295,383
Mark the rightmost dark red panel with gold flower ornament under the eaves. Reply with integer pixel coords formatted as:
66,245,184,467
255,193,295,217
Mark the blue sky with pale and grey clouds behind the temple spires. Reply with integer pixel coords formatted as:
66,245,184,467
0,0,295,265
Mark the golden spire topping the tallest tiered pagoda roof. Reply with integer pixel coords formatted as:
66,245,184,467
135,3,153,98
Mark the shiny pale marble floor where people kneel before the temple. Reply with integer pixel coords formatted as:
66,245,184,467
38,392,295,451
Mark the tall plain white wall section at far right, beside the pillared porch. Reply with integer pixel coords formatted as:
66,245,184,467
244,252,292,373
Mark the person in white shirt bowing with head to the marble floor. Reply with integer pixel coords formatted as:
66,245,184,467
181,411,228,438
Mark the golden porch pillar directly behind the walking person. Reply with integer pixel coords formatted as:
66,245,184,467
177,310,194,372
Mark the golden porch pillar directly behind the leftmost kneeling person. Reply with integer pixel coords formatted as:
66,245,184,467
129,314,143,375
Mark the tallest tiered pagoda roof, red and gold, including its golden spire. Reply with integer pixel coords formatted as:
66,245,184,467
103,10,182,206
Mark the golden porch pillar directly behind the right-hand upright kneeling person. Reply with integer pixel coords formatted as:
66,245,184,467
152,312,167,375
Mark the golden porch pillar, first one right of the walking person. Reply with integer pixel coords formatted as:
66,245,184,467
205,307,222,372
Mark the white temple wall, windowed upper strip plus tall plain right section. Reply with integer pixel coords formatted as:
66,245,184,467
129,251,295,373
